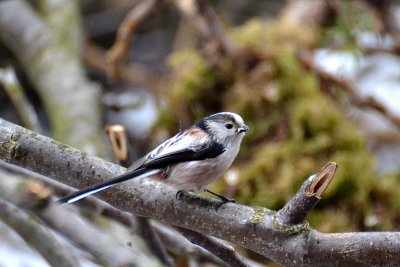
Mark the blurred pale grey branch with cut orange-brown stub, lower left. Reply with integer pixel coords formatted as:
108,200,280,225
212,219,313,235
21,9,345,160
0,172,162,267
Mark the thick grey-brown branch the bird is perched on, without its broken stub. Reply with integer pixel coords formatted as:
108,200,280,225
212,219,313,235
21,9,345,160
0,119,400,266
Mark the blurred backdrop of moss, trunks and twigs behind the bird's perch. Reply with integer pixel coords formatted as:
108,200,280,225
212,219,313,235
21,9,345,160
0,0,400,266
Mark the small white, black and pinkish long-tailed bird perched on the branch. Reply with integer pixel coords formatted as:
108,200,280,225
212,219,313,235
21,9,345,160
58,112,249,203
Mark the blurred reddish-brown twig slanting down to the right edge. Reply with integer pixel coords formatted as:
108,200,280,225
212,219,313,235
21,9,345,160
299,52,400,129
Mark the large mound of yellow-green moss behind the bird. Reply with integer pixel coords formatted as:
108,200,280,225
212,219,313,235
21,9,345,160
153,15,400,231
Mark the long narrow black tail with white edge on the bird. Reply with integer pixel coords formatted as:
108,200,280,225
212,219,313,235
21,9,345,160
57,168,159,204
